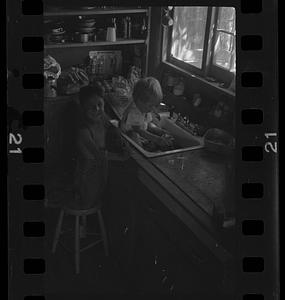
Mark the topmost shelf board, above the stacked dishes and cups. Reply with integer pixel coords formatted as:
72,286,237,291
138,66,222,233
44,8,148,17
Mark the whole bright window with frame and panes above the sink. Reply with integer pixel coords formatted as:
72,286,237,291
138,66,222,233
166,6,236,84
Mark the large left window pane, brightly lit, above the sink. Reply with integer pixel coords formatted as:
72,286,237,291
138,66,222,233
171,6,208,69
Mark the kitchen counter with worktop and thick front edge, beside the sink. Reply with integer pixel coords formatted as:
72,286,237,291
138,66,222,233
105,96,234,264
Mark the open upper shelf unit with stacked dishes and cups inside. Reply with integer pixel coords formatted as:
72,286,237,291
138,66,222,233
44,6,150,49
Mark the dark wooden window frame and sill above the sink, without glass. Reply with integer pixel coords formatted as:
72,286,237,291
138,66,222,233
162,6,237,86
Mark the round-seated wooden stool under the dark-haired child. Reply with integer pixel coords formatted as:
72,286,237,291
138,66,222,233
52,207,109,274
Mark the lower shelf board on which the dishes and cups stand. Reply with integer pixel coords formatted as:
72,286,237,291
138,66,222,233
44,39,145,49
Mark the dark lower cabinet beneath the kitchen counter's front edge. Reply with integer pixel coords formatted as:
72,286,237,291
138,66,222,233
130,171,233,299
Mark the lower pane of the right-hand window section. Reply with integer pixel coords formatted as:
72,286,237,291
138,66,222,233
214,32,236,72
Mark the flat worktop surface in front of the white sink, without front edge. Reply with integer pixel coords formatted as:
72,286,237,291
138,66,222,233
104,96,234,216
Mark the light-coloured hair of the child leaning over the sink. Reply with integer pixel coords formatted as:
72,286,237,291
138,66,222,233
133,77,163,102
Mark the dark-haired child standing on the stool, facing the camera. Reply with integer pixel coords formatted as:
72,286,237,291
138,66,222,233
72,85,127,209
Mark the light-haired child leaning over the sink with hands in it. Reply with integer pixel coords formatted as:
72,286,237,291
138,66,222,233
121,77,171,147
